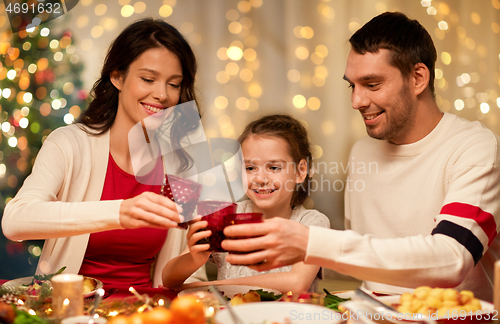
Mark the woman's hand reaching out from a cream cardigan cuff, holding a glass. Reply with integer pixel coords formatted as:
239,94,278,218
120,192,184,229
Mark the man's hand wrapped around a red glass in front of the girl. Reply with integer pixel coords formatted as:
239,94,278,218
222,217,309,271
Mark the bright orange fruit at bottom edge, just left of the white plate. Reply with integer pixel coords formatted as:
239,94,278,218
170,295,205,324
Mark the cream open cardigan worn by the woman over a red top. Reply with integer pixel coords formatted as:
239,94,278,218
2,125,206,287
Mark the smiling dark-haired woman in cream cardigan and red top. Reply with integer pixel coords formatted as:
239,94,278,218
2,18,205,287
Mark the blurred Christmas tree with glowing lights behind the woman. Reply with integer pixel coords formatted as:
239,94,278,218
0,17,87,278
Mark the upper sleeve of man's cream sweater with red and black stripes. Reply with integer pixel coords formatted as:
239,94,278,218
432,132,500,264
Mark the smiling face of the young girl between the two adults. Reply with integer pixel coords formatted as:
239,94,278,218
241,136,307,217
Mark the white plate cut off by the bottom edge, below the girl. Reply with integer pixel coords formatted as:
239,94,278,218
215,302,342,324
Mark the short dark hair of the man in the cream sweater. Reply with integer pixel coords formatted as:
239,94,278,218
349,12,437,96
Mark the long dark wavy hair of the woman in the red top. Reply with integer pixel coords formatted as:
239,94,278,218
76,18,200,170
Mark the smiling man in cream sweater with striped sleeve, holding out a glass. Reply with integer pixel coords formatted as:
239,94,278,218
223,13,500,301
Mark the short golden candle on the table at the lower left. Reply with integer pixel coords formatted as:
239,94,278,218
51,274,83,319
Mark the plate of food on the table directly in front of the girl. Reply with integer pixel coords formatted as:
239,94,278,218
178,285,282,305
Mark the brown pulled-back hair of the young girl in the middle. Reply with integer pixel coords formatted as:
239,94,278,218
238,115,312,208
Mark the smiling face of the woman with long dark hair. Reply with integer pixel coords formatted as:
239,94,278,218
111,47,182,128
